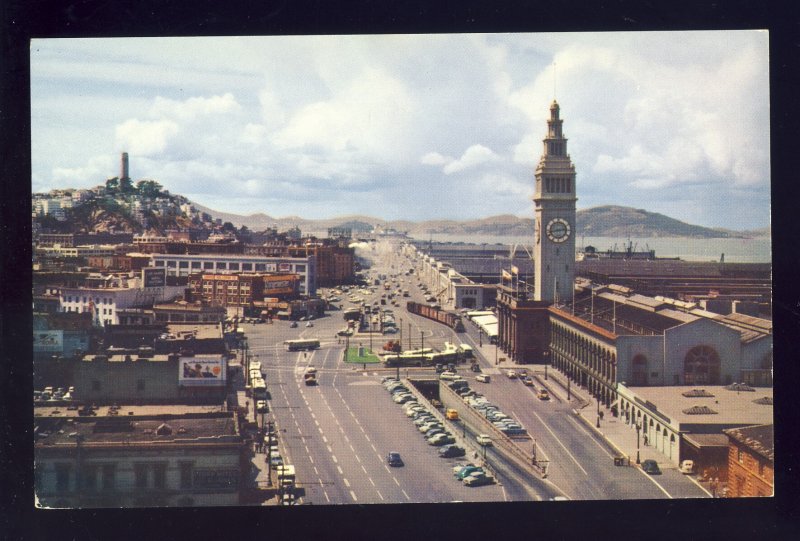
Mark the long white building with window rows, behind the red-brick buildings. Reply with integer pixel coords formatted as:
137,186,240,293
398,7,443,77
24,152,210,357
152,254,317,296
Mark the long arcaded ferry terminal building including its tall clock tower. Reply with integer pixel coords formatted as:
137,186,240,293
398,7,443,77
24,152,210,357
497,101,772,407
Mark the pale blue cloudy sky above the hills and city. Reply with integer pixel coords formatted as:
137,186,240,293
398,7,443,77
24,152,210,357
31,31,770,229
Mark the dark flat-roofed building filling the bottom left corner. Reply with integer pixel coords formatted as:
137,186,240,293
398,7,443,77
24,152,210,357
34,406,249,508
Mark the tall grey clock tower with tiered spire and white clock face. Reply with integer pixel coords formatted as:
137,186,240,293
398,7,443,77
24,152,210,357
533,100,578,302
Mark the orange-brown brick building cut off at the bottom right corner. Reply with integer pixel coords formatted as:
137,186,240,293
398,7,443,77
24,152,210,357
724,424,775,498
